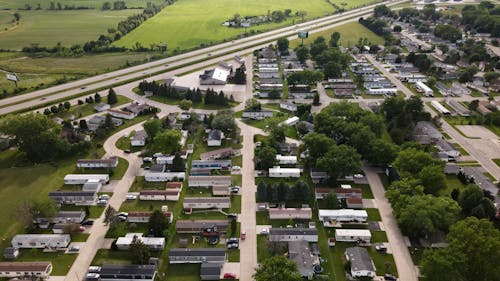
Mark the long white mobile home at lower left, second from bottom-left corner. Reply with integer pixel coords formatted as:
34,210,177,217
11,234,71,249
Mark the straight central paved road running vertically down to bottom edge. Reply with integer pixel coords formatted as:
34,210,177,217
238,121,257,280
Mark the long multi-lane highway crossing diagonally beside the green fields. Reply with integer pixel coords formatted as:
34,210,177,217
0,1,404,115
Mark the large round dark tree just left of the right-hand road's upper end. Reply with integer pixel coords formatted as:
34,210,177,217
317,145,361,180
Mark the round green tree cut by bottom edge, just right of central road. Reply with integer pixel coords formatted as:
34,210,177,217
253,255,302,281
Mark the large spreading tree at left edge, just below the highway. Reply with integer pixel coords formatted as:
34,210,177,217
0,113,69,162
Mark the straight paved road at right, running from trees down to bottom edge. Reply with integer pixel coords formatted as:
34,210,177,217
363,166,418,281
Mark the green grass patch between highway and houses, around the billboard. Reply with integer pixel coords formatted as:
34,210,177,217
290,22,384,48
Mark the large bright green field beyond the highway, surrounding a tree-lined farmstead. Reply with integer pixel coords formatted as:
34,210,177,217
115,0,338,50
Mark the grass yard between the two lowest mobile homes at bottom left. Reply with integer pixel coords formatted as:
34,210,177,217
12,249,77,276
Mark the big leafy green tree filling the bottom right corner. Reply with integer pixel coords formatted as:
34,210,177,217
421,217,500,281
